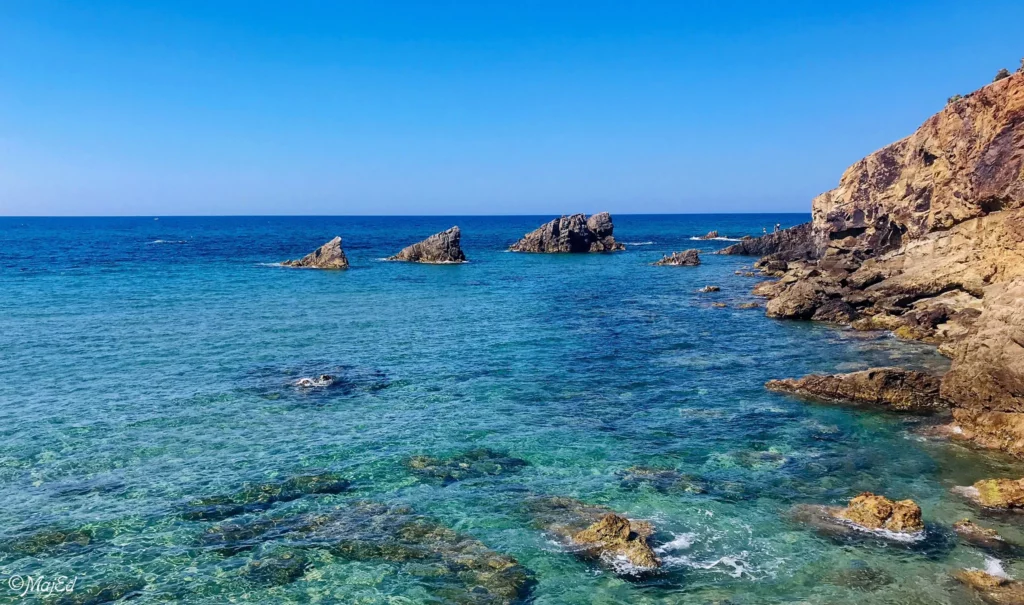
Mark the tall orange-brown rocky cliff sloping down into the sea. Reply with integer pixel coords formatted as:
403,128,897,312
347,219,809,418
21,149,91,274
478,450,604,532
721,73,1024,458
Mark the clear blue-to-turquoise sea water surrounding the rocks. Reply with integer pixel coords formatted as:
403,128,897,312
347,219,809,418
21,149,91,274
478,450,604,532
0,215,1024,604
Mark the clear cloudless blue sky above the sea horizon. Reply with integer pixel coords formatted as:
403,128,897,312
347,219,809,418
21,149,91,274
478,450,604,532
0,0,1024,215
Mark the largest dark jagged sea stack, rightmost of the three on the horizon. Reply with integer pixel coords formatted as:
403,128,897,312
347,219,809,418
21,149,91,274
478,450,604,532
509,212,626,252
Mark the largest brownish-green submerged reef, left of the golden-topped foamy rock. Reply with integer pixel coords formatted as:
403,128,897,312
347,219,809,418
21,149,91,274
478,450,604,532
203,502,534,605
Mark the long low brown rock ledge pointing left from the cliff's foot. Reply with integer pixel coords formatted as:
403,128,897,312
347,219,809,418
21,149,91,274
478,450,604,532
765,368,948,414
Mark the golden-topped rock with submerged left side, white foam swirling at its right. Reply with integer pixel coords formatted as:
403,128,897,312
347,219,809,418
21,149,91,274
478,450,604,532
527,498,662,574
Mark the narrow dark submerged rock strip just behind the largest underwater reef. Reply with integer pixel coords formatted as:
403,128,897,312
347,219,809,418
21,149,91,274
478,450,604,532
181,473,348,521
